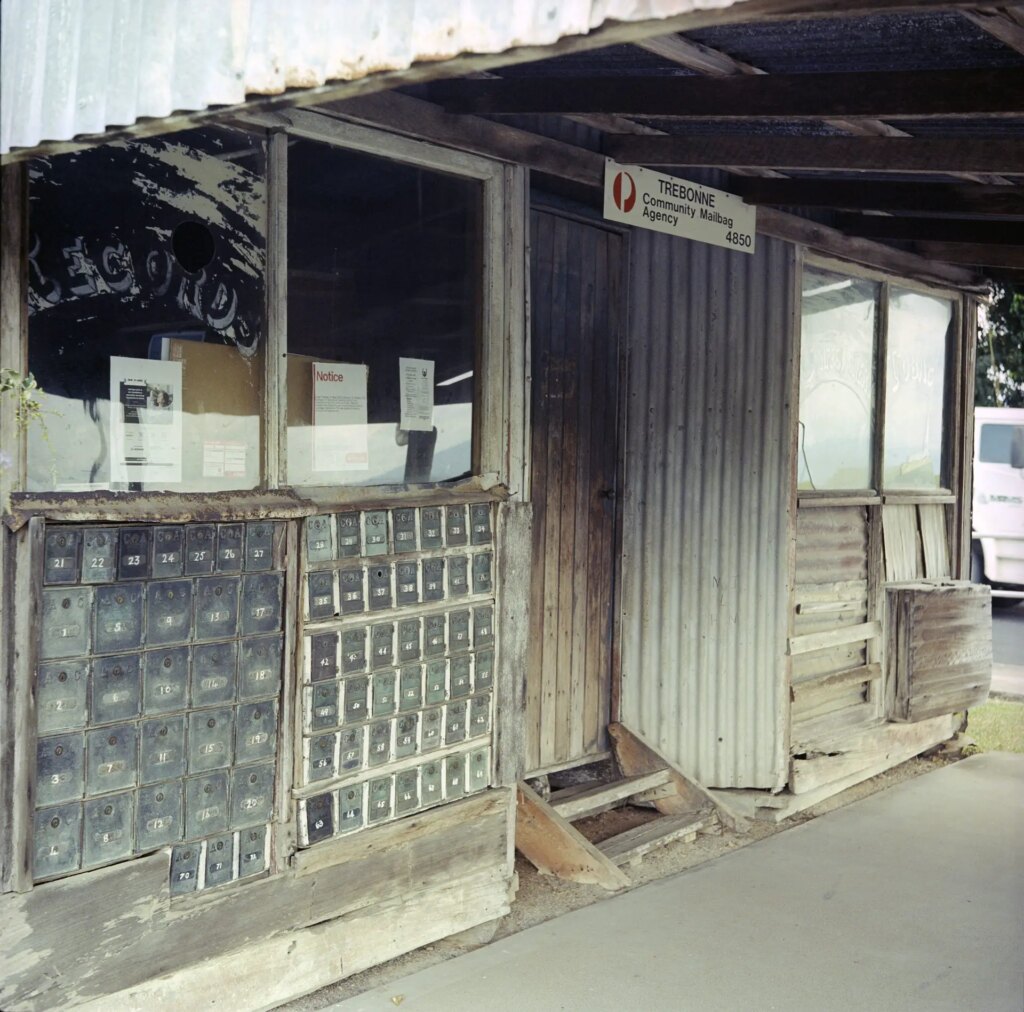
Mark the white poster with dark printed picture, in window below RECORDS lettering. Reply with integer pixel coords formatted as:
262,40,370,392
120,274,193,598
111,355,181,484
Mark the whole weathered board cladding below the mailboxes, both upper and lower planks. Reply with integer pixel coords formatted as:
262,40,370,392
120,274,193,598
0,789,514,1012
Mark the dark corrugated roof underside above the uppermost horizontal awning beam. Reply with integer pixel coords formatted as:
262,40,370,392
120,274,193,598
686,10,1024,74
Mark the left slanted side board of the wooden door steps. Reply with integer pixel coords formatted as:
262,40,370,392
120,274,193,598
515,784,630,891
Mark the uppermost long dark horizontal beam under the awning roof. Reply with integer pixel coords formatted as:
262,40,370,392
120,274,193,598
429,69,1024,119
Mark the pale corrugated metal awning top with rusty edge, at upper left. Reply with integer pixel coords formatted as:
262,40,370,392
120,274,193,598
0,0,745,153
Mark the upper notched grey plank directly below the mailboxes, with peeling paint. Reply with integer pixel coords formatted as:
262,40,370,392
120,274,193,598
0,790,511,1012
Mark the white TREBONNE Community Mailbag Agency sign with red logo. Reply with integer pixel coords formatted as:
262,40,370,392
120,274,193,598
604,158,757,253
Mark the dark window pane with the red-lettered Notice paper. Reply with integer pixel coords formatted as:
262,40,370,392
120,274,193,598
288,140,482,484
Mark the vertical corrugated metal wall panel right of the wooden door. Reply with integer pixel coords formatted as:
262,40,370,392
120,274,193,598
622,231,795,788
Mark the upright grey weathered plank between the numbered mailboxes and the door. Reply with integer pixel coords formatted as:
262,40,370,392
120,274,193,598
495,502,534,787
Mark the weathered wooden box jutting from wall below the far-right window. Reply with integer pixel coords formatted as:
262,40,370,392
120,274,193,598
886,582,992,722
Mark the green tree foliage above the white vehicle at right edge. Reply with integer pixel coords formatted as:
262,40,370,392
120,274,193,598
974,284,1024,408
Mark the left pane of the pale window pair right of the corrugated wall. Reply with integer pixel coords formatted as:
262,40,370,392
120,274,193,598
798,269,879,489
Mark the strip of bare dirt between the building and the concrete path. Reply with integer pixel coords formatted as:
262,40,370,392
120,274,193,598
281,751,961,1012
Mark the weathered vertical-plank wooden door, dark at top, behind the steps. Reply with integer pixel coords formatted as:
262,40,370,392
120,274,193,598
526,209,626,772
